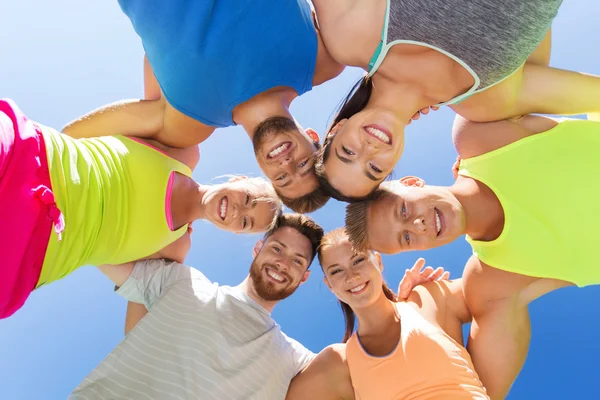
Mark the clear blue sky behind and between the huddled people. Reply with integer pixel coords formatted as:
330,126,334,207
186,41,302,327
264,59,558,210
0,0,600,400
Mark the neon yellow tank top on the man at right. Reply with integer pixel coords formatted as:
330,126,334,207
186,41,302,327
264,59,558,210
459,120,600,286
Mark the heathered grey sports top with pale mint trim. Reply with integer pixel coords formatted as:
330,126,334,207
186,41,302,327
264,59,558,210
369,0,562,106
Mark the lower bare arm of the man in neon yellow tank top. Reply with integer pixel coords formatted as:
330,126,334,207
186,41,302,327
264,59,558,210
463,256,571,400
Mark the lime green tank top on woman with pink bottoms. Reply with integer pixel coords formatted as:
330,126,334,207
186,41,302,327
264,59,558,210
37,125,192,287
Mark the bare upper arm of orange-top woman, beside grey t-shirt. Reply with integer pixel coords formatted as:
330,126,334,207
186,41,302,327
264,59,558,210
286,344,354,400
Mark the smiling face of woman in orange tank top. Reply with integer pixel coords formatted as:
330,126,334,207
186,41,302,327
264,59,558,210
321,240,383,309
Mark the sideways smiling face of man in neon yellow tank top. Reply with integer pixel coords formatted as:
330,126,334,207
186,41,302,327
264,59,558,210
367,181,465,254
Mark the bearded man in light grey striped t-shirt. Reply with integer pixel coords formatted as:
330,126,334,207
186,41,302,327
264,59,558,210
70,214,323,400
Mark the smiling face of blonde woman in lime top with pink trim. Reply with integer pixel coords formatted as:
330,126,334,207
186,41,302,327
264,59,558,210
202,177,278,233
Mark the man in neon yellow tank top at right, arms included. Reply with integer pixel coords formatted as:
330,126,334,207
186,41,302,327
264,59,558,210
346,115,600,398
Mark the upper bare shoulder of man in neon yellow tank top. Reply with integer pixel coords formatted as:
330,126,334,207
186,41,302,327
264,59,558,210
452,115,558,159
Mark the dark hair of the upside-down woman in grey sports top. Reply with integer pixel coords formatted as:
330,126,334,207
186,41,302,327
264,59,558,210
315,76,373,203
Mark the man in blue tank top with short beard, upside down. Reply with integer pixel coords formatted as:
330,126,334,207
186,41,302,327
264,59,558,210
64,0,344,212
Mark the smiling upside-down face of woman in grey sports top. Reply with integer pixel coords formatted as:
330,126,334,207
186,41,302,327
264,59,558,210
323,108,405,197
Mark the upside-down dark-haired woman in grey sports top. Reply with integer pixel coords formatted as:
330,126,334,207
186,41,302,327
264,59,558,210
314,0,600,201
